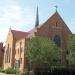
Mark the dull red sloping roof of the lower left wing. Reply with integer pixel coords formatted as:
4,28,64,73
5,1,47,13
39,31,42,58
11,30,29,40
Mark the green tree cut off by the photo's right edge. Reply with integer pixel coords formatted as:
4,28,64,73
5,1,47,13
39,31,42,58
68,35,75,65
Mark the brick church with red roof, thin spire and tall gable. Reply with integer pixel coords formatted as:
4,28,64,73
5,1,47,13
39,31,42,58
0,8,72,70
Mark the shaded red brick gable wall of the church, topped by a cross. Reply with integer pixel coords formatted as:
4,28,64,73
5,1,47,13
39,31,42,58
31,12,72,64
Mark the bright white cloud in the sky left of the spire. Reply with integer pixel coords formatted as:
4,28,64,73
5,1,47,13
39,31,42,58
0,0,34,42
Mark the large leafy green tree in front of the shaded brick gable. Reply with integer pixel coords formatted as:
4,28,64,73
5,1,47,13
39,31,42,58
27,37,61,68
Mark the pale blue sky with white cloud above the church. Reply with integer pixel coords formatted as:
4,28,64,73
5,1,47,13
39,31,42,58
0,0,75,42
